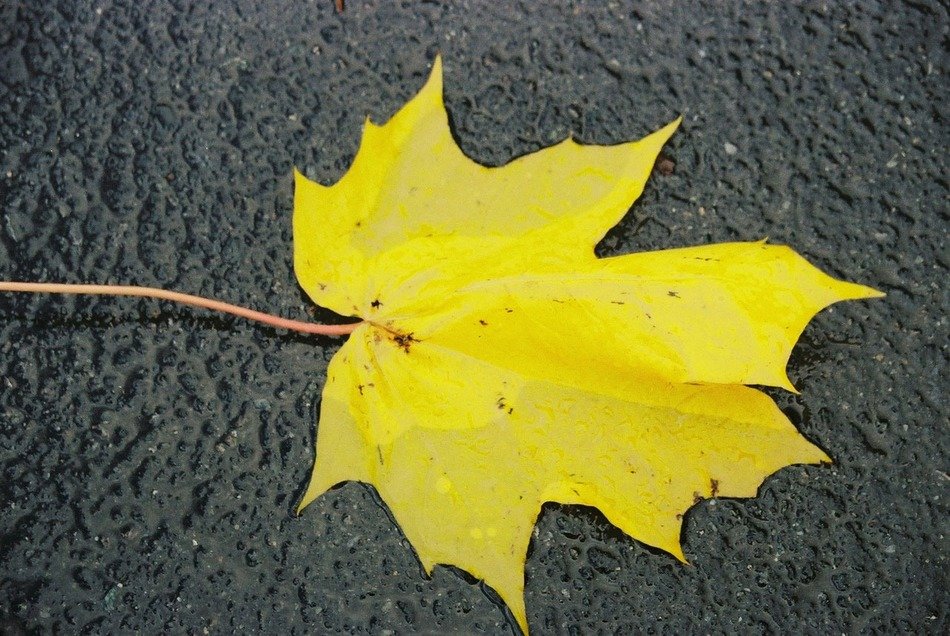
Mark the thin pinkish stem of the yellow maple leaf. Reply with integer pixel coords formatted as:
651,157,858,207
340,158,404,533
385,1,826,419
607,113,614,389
0,281,363,336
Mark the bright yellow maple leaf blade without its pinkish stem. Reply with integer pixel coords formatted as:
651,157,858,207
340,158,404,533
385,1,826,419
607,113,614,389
294,59,880,630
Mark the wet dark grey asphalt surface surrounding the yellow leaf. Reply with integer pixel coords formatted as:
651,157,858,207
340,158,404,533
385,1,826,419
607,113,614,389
0,0,950,634
